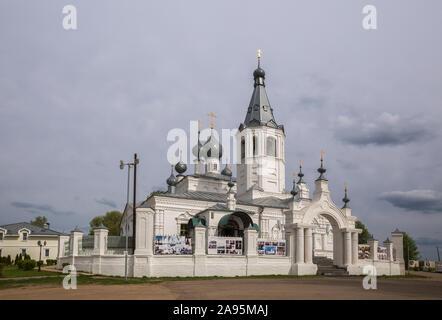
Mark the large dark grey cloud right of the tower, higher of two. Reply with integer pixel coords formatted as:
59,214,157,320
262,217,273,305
335,112,433,146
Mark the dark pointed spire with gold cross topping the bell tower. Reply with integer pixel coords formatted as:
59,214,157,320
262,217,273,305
239,49,284,131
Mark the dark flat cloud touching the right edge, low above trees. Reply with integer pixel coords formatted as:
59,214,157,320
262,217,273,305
380,190,442,213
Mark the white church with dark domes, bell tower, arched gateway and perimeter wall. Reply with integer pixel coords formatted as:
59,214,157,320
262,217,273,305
58,52,404,277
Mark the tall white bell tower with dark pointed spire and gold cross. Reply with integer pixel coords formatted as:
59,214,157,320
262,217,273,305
236,50,285,195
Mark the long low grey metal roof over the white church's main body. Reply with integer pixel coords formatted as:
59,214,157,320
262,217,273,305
157,191,289,209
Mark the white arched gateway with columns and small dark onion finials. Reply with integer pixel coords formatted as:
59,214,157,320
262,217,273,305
285,165,361,275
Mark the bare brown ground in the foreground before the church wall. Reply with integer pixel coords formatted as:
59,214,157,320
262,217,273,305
0,273,442,300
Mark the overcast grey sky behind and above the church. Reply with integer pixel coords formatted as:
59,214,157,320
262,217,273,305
0,0,442,259
